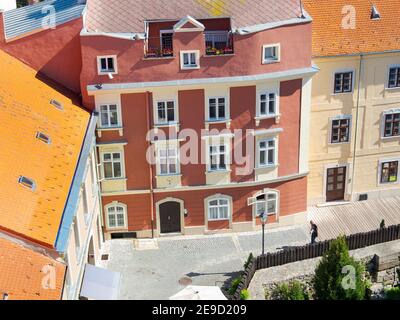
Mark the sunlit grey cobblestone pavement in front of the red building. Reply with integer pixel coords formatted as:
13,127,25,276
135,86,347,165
104,226,309,300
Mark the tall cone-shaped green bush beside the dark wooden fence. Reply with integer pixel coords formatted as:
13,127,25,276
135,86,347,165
313,237,368,300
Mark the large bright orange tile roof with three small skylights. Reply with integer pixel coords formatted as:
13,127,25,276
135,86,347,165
0,50,90,247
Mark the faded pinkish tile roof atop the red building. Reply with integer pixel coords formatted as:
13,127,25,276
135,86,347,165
87,0,301,33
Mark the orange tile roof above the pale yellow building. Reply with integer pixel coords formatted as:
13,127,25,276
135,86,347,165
303,0,400,57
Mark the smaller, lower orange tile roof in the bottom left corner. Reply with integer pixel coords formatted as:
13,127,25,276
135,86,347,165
0,238,66,300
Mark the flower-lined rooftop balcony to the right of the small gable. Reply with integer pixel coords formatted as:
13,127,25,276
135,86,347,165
205,31,234,56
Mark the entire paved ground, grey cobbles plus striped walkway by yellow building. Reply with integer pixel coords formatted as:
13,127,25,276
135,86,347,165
104,197,400,300
